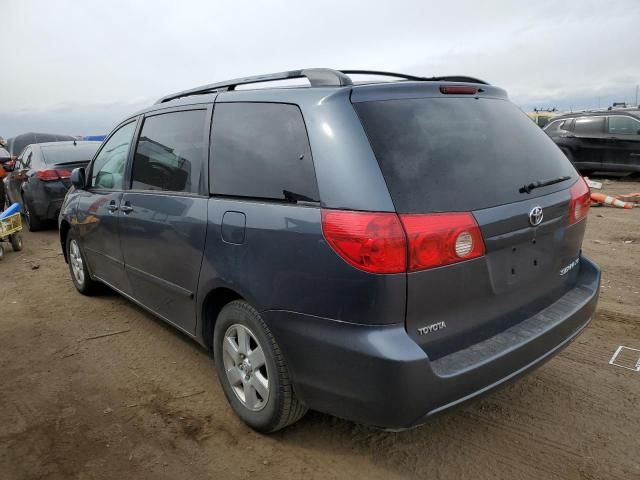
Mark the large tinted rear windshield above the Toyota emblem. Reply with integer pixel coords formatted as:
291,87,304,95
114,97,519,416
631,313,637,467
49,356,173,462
354,98,577,213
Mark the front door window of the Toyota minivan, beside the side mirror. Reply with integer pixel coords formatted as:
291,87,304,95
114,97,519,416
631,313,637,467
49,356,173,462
91,122,136,190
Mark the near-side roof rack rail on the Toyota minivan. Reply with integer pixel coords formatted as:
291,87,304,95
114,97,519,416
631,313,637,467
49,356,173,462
156,68,353,104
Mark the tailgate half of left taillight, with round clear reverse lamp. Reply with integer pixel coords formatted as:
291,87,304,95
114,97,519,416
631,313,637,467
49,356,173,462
400,212,484,272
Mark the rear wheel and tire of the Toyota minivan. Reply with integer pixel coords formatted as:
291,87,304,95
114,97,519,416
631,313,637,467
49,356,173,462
213,300,307,433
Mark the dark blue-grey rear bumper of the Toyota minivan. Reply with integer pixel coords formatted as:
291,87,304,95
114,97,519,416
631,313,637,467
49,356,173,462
263,257,600,429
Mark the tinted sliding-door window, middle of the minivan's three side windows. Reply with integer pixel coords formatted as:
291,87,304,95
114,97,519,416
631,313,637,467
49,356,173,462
131,110,207,193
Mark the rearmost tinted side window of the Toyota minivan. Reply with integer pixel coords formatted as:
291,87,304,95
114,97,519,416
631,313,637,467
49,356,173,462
211,103,319,201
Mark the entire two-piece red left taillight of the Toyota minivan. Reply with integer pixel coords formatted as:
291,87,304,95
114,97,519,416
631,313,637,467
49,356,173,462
322,210,484,273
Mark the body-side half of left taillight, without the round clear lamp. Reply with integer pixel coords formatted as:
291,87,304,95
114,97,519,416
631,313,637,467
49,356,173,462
322,210,407,273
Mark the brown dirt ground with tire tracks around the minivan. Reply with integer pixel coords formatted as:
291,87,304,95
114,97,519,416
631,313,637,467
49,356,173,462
0,178,640,480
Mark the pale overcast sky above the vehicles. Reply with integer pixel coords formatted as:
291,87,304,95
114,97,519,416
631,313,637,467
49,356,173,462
0,0,640,138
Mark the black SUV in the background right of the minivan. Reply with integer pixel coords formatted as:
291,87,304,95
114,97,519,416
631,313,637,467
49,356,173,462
544,109,640,175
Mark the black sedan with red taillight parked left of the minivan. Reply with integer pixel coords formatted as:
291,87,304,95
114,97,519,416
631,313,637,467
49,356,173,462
4,141,100,231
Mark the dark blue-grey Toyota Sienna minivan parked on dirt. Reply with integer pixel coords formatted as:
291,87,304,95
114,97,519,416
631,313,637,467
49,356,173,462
60,69,600,432
